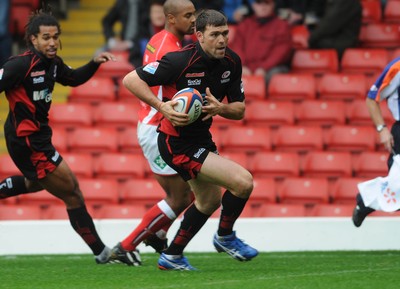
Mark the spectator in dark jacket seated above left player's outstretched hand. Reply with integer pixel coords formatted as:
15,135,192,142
101,0,140,51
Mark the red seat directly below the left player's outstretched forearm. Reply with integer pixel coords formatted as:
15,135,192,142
68,76,116,104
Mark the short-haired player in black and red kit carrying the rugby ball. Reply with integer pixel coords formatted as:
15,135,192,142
123,10,258,270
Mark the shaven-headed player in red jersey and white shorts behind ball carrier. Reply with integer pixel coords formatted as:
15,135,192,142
105,0,195,265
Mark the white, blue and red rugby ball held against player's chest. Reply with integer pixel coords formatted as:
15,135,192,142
172,87,203,124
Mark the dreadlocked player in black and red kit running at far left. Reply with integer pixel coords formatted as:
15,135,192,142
0,9,119,263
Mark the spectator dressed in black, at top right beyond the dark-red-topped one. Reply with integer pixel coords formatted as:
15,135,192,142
308,0,362,58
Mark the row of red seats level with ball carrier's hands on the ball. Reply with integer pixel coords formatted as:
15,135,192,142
49,97,392,130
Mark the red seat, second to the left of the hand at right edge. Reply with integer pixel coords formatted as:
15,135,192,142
273,125,323,153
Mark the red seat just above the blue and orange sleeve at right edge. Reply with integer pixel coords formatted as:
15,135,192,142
341,48,389,75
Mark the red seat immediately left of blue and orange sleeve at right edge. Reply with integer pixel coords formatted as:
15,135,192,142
318,73,368,100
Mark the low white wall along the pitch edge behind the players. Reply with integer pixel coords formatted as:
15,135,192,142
0,217,400,255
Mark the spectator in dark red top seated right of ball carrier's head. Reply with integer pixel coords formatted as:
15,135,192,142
231,0,292,84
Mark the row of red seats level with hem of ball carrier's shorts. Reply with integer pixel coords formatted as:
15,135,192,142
0,151,387,181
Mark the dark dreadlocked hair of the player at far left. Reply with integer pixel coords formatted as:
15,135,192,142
24,6,61,47
